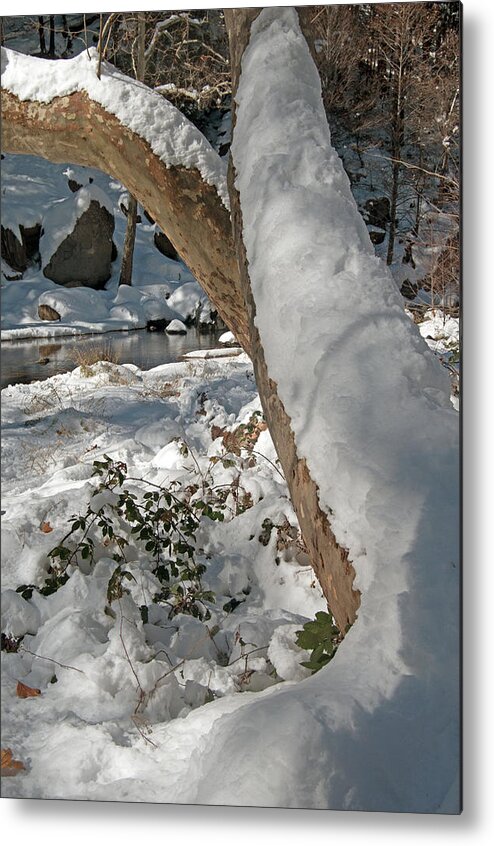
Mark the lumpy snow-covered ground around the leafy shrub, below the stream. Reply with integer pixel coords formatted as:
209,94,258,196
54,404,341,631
2,354,324,803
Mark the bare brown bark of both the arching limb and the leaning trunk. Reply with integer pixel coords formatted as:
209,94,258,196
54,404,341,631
2,39,360,631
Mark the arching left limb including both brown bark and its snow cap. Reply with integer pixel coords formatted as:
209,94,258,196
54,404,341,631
1,48,249,352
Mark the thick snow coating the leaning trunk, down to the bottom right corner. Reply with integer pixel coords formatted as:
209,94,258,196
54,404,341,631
191,8,460,813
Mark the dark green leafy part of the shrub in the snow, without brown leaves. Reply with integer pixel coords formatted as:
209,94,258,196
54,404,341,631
17,455,224,619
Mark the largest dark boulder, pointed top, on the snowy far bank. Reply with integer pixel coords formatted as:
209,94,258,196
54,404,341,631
43,199,115,288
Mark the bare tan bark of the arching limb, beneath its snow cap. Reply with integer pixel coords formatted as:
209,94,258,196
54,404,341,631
1,83,250,352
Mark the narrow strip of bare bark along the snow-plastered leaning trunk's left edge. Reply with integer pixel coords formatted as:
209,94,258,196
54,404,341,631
225,4,360,632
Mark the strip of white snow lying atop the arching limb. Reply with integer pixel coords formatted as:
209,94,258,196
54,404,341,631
1,47,229,208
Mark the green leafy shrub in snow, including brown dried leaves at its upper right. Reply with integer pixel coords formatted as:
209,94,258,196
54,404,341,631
17,412,283,621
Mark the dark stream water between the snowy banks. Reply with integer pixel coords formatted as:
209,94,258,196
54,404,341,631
0,329,224,388
